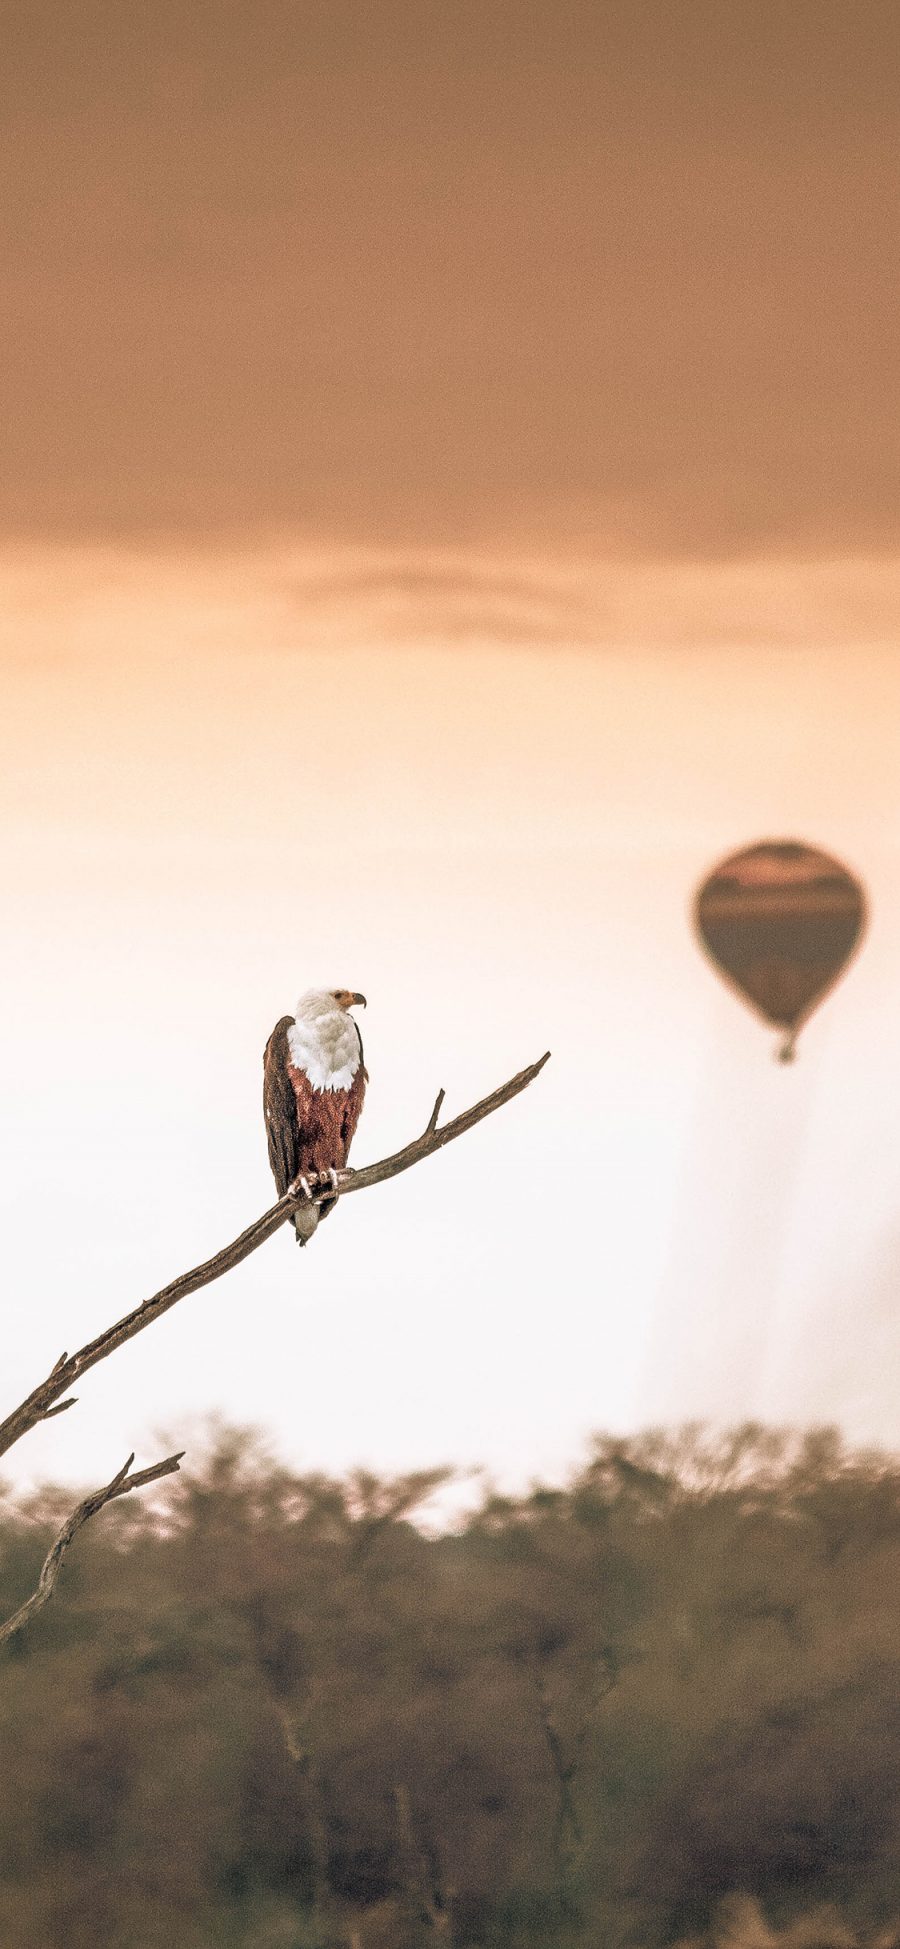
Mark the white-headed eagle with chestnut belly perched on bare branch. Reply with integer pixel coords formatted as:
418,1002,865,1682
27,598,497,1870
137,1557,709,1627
263,988,368,1245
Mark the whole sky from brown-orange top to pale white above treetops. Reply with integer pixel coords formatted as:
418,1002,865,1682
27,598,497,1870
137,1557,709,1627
0,0,900,1483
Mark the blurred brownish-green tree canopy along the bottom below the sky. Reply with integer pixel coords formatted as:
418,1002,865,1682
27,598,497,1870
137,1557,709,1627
0,1429,900,1949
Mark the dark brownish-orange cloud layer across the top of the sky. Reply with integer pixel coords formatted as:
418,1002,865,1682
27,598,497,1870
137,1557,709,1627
0,0,900,559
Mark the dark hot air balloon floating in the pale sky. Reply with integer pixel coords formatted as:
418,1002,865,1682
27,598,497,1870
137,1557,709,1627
694,840,865,1062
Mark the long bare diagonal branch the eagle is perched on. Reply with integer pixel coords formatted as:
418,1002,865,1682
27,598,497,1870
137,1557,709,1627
0,1051,549,1465
